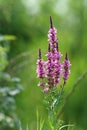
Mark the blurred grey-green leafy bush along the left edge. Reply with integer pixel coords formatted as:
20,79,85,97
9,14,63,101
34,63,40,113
0,36,22,130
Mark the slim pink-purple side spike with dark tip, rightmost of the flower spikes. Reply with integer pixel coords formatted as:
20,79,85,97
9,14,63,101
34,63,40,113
63,53,71,84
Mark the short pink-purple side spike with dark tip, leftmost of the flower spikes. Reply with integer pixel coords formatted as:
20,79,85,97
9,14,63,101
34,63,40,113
36,49,45,79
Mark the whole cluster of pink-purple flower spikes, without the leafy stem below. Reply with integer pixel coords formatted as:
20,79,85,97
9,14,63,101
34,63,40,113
37,17,71,92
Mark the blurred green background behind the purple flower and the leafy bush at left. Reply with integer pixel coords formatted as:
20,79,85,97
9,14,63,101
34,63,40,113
0,0,87,130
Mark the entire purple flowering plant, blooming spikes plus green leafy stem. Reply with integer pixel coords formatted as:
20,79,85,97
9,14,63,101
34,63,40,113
36,16,71,129
